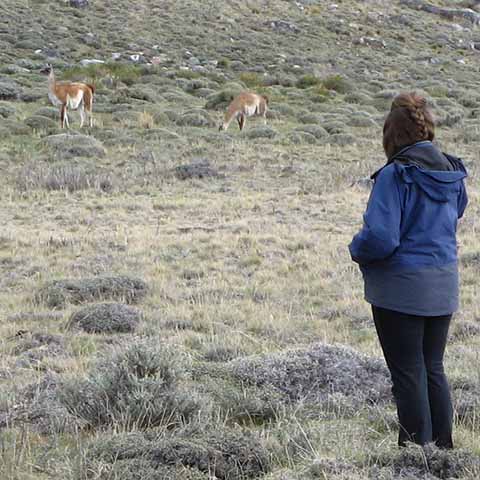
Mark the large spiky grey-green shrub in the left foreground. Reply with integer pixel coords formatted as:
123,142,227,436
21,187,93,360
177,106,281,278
59,342,198,428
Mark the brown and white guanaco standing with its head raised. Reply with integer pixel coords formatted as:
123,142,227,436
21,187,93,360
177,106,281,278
40,64,95,128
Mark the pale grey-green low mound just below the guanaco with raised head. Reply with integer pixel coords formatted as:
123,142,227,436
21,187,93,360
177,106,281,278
42,133,106,160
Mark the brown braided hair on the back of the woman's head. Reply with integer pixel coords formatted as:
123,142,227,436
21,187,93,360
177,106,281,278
383,92,435,160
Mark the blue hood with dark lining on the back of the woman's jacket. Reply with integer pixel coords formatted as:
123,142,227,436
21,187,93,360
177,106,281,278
374,141,467,202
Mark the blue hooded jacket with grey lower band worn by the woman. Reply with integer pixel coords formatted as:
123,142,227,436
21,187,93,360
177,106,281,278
349,141,467,316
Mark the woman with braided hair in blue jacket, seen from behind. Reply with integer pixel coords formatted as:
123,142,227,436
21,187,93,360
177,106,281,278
349,93,467,448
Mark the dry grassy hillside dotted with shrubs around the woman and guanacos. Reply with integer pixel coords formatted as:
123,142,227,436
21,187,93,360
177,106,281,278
0,0,480,480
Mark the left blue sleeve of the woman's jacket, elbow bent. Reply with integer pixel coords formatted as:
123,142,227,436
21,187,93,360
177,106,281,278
349,165,402,265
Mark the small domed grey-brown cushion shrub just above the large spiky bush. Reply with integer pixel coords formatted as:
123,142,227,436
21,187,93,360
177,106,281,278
68,303,142,333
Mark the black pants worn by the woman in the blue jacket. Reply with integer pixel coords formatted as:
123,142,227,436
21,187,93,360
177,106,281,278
372,305,453,448
